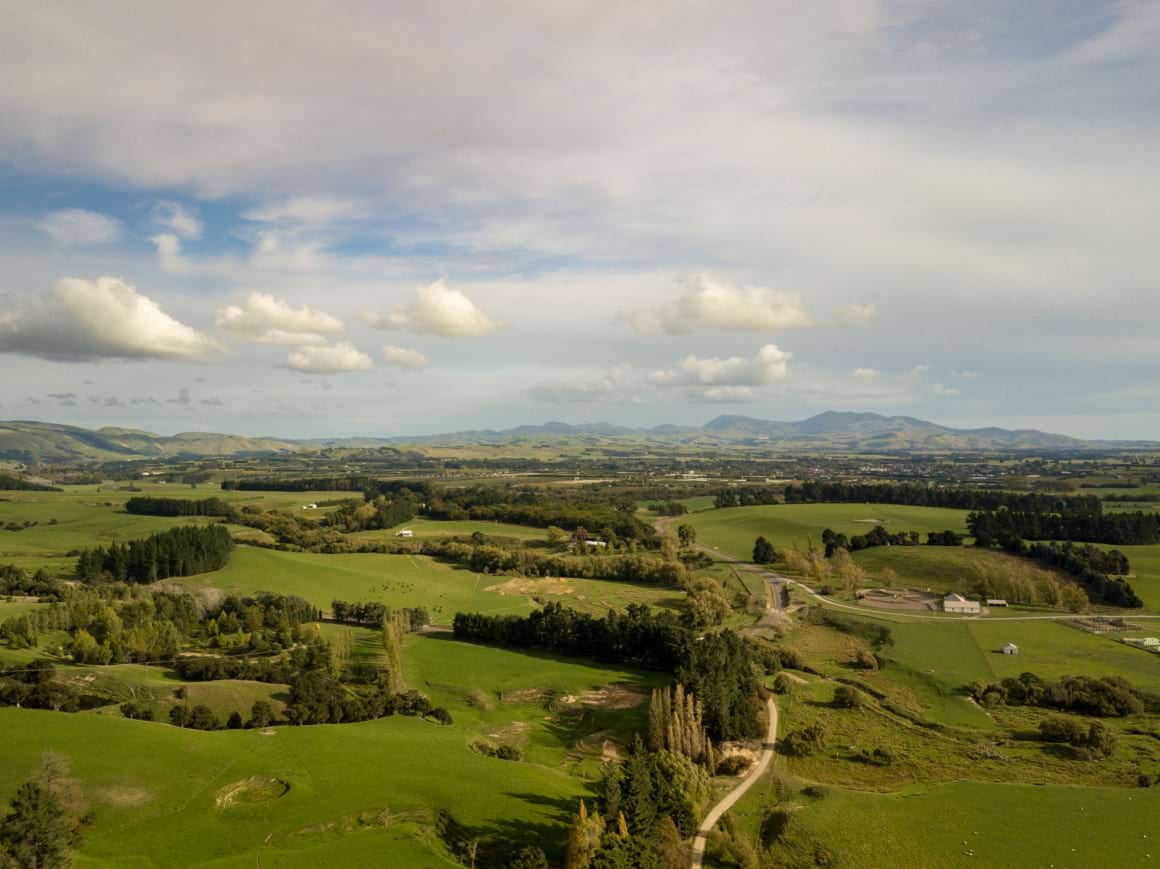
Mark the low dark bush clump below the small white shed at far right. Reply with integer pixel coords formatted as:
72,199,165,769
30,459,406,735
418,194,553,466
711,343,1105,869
970,673,1155,718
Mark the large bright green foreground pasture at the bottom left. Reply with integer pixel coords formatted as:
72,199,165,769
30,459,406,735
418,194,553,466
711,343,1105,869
0,708,586,867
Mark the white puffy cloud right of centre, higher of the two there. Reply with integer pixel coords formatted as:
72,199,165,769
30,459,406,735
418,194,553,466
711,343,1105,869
621,273,815,335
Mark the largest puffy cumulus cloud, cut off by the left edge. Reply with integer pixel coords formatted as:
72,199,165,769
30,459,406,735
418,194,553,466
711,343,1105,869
0,277,220,362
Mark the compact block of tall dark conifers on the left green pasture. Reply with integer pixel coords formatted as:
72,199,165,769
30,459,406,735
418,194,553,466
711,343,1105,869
77,526,233,582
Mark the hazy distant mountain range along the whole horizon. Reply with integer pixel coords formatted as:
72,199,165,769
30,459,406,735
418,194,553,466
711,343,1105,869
0,411,1160,464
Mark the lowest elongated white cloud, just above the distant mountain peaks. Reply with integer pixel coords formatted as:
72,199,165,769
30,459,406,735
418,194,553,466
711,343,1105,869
528,343,792,401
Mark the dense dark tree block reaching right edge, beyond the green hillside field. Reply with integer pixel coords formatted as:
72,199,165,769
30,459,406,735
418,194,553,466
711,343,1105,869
966,508,1160,545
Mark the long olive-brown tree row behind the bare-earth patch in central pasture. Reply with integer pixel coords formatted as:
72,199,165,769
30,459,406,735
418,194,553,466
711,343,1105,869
433,541,689,586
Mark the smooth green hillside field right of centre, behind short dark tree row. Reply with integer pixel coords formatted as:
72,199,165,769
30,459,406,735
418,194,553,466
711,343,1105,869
681,504,967,560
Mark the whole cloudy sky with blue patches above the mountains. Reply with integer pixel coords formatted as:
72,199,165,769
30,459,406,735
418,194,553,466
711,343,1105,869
0,0,1160,439
